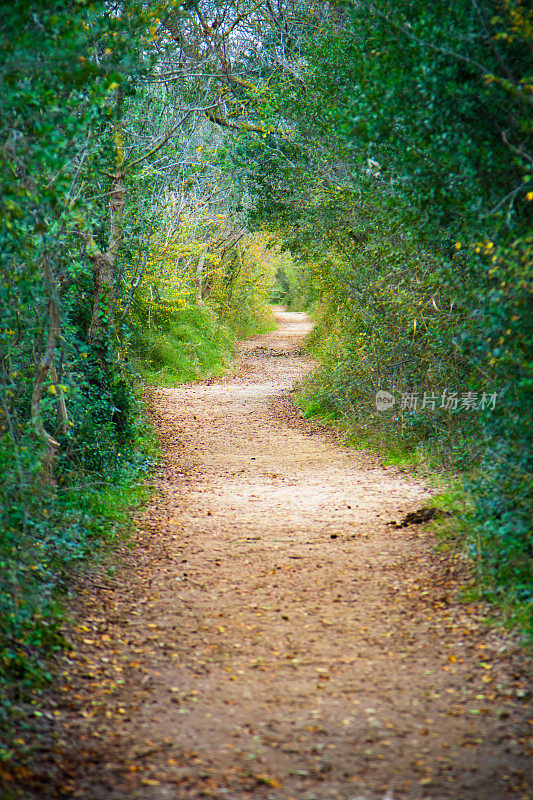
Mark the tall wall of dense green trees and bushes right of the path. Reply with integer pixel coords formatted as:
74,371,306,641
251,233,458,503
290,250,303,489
234,0,533,624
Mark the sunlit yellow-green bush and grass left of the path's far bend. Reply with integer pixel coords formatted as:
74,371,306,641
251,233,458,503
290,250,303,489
123,223,277,385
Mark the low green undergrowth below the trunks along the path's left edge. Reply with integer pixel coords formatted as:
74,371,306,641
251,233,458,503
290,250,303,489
0,384,157,761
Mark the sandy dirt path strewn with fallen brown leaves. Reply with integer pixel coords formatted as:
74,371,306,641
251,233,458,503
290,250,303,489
18,311,528,800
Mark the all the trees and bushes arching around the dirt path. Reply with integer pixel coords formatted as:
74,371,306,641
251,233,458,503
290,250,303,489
0,0,533,752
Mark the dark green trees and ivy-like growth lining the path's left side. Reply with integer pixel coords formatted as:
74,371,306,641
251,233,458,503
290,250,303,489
0,0,157,725
